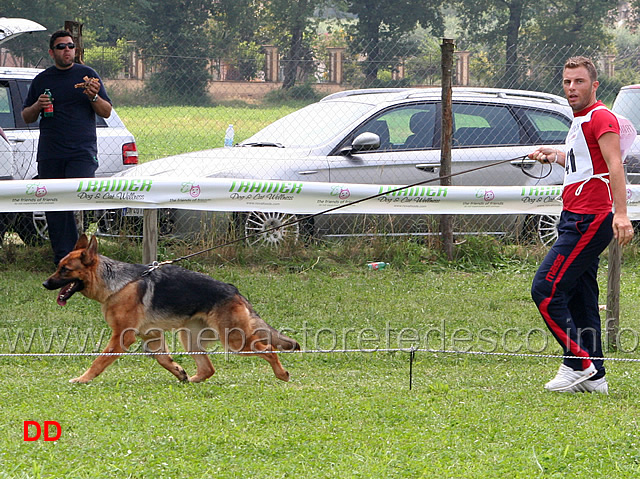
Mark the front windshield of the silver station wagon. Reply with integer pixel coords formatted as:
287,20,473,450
241,101,374,148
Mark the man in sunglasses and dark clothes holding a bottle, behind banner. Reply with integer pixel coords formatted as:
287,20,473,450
22,30,111,265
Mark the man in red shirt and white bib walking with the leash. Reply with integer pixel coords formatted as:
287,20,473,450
529,57,633,394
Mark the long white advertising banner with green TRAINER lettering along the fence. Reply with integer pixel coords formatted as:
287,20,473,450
0,177,640,219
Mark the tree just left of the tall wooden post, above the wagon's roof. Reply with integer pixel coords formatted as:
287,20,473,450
346,0,443,85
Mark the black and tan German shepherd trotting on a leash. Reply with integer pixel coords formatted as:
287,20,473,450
43,234,300,383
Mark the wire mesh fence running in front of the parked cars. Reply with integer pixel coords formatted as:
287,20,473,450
0,42,640,260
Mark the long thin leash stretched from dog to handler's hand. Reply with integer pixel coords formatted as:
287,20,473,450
142,155,553,276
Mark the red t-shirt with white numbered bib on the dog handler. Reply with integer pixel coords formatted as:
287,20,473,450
562,101,620,214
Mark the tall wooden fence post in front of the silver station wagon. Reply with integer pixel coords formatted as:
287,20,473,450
440,38,454,261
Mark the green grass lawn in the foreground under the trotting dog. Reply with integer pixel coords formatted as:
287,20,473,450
0,256,640,478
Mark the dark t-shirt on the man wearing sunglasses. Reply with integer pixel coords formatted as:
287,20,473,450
23,63,111,161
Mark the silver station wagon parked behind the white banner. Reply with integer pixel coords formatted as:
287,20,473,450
112,88,572,243
